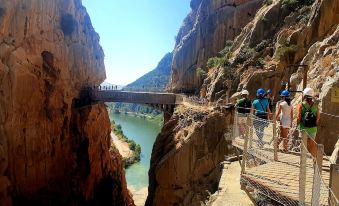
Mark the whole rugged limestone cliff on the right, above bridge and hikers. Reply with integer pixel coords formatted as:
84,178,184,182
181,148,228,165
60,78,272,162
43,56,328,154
171,0,339,154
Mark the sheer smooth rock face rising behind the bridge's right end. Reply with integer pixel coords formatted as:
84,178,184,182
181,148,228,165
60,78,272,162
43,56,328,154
170,0,262,92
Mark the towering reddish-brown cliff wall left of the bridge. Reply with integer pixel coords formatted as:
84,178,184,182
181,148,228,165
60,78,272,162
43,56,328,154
0,0,133,205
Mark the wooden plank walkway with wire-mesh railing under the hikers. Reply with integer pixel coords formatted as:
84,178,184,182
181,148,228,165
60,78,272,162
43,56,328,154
233,112,339,205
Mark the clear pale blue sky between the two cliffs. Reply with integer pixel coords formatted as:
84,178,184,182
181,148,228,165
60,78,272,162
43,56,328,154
82,0,190,85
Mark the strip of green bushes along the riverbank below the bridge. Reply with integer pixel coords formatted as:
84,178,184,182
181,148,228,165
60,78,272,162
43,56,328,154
111,120,141,168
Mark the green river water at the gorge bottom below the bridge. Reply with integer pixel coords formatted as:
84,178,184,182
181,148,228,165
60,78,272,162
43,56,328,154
110,114,161,189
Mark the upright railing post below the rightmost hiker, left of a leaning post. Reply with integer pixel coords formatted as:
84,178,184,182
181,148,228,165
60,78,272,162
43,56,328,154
299,131,307,206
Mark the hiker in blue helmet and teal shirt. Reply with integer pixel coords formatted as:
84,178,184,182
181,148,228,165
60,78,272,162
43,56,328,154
251,88,271,148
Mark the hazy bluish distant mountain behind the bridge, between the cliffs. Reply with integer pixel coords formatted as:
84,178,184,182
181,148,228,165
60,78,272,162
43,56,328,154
123,53,173,91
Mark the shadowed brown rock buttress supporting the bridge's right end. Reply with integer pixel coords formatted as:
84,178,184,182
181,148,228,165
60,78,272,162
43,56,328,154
146,105,232,206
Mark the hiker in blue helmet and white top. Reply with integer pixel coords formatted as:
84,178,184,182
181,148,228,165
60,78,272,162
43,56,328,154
276,90,293,152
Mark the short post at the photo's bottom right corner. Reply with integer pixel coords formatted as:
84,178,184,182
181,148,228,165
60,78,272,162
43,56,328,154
328,164,339,206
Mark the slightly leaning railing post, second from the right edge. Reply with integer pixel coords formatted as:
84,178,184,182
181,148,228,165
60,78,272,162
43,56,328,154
311,144,324,206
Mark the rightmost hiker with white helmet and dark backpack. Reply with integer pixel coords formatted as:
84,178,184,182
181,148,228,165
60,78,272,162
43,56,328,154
297,88,320,139
